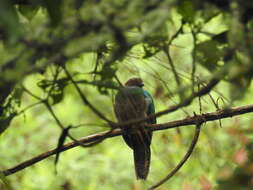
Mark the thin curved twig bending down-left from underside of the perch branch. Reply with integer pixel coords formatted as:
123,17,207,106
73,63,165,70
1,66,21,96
147,124,201,190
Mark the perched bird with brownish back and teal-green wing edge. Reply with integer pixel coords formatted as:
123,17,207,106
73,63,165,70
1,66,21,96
114,77,156,180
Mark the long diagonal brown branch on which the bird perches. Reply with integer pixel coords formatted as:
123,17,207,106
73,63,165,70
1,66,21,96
2,104,253,176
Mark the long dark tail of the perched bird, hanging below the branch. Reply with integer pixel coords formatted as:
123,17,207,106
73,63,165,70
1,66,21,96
133,145,151,180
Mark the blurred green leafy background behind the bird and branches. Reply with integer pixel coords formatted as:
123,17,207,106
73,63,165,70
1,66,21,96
0,0,253,190
